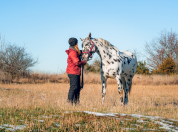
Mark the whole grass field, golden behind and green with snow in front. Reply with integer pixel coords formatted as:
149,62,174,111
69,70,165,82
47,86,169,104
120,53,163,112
0,74,178,131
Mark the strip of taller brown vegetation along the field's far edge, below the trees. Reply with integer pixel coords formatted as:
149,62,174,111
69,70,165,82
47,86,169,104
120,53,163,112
0,71,178,85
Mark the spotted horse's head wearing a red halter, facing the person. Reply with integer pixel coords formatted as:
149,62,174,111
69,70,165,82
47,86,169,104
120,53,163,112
81,33,96,61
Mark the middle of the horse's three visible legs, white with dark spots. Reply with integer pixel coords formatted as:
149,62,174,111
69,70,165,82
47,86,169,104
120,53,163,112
116,75,123,102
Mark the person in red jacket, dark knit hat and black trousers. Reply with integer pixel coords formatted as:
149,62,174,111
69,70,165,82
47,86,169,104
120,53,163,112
66,38,86,104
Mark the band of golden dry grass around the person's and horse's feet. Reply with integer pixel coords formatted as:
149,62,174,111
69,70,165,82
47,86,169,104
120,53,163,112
0,83,178,119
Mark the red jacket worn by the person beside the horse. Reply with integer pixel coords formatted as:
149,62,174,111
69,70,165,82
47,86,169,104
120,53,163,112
66,48,86,75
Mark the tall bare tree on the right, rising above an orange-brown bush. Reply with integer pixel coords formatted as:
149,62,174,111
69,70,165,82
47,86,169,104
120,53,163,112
145,30,178,69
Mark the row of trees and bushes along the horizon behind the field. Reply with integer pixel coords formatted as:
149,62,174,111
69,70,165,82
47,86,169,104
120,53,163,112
0,30,178,81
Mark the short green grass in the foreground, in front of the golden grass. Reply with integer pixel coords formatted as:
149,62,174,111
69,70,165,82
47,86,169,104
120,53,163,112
0,108,178,132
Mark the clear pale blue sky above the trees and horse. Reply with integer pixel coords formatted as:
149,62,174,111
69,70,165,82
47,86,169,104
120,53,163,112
0,0,178,73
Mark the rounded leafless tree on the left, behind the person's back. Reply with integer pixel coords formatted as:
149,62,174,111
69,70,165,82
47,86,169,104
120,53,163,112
0,44,37,79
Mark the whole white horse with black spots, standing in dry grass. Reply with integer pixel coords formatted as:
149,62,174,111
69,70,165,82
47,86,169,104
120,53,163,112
81,33,137,105
